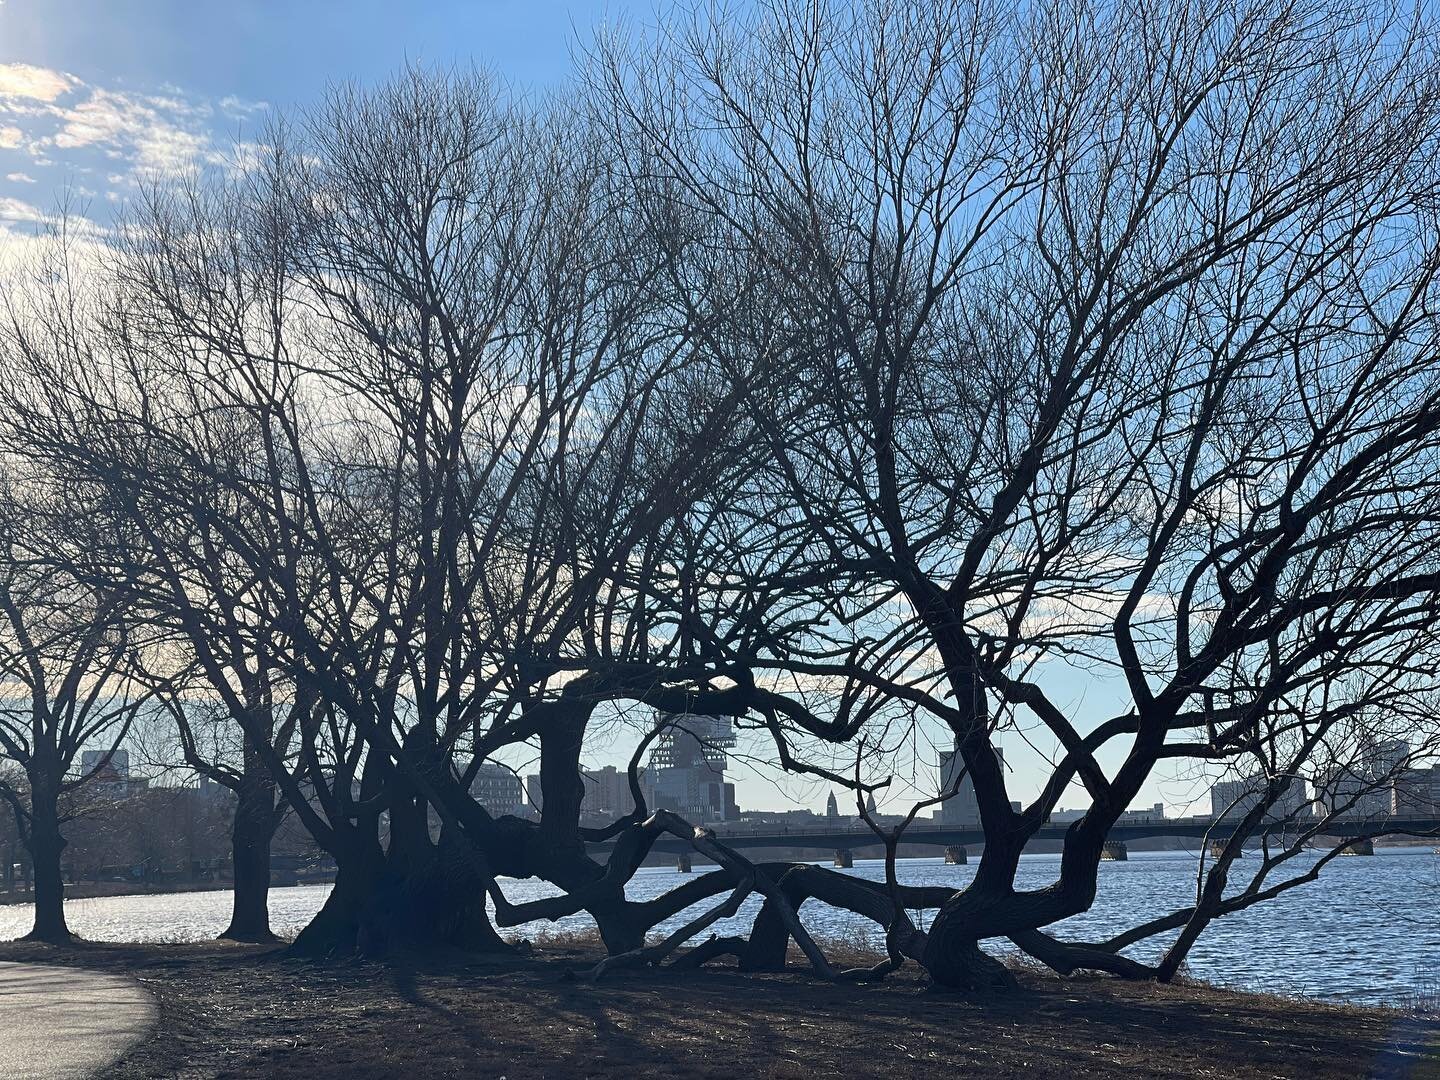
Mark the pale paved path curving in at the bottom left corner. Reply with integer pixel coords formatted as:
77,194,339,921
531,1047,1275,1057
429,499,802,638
0,963,156,1080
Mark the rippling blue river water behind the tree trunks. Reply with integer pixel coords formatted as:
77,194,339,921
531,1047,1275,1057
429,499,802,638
0,848,1440,1004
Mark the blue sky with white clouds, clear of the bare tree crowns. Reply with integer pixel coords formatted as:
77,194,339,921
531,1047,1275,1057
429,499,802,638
0,0,1202,809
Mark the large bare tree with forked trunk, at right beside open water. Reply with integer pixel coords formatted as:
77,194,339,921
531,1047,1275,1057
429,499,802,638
596,0,1440,985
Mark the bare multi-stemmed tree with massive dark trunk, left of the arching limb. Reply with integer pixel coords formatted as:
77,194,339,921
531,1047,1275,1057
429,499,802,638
2,72,766,952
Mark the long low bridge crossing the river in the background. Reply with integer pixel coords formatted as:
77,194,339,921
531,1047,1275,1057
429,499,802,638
576,818,1440,854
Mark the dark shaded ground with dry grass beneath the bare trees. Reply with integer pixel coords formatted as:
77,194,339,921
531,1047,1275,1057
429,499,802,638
0,942,1440,1080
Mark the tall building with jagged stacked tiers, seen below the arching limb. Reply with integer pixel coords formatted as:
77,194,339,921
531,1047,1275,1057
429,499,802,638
641,713,739,822
